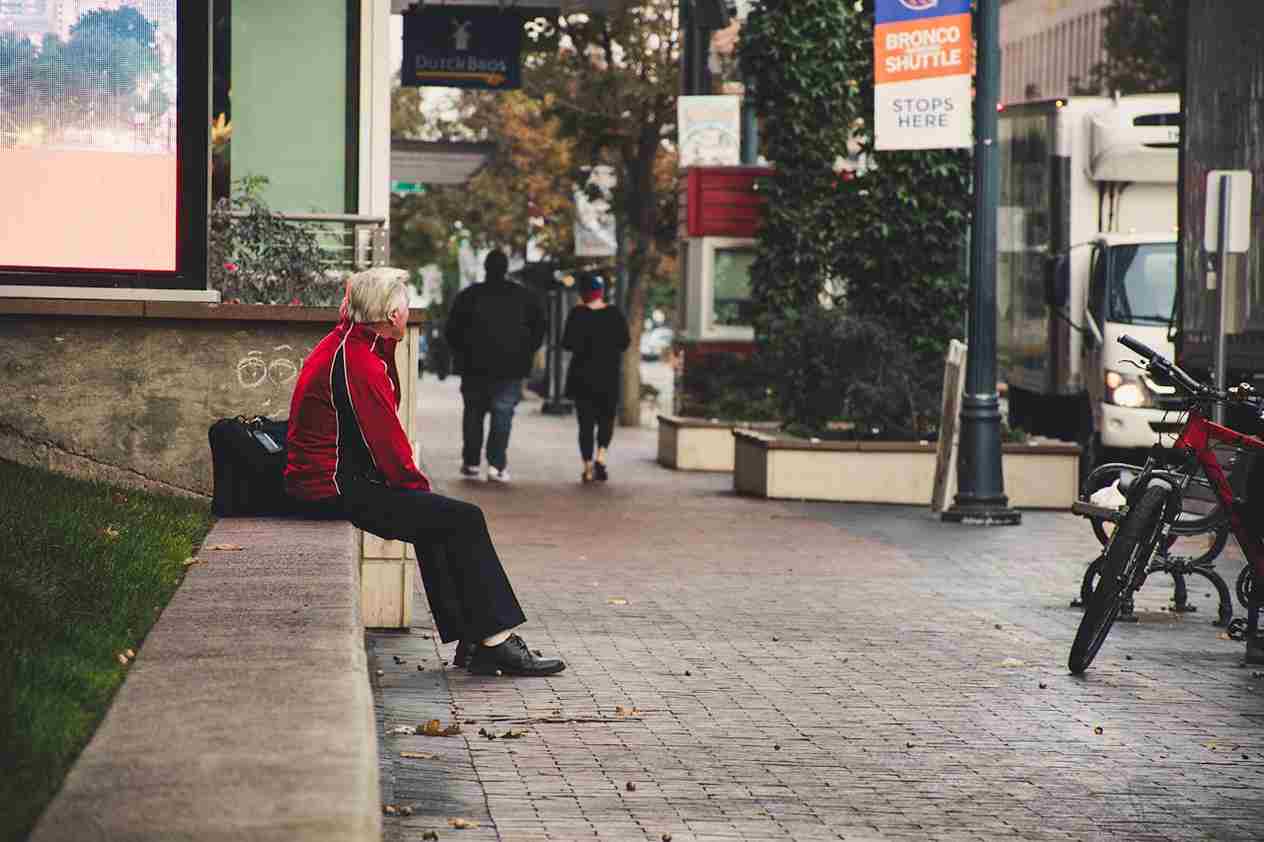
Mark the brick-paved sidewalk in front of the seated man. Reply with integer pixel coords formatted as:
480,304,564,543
368,379,1264,842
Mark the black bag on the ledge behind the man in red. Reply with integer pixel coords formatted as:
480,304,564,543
207,415,295,517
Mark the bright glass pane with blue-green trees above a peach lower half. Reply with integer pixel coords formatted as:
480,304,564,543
0,0,179,272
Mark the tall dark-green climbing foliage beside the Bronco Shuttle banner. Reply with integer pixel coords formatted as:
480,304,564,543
739,0,971,431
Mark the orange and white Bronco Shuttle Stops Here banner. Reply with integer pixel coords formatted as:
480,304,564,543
873,0,975,149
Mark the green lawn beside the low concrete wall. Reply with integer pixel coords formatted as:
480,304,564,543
0,460,211,841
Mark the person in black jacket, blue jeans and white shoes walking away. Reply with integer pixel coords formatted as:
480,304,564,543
445,249,545,483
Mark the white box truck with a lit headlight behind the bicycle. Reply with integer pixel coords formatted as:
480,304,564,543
996,94,1181,469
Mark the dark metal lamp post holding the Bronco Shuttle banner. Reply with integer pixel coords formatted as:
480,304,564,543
942,0,1023,525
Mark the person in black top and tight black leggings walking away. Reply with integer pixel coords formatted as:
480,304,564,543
561,276,632,483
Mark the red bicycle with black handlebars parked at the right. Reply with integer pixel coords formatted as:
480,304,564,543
1067,336,1264,674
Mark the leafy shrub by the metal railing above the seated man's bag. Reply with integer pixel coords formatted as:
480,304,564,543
207,176,341,307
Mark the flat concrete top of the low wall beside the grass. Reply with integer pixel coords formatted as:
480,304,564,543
30,518,382,842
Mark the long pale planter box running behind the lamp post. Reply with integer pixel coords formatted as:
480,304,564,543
733,430,1079,509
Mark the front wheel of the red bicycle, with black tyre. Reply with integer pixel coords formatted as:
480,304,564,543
1067,485,1168,675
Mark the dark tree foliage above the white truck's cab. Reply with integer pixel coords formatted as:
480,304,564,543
1077,0,1189,94
